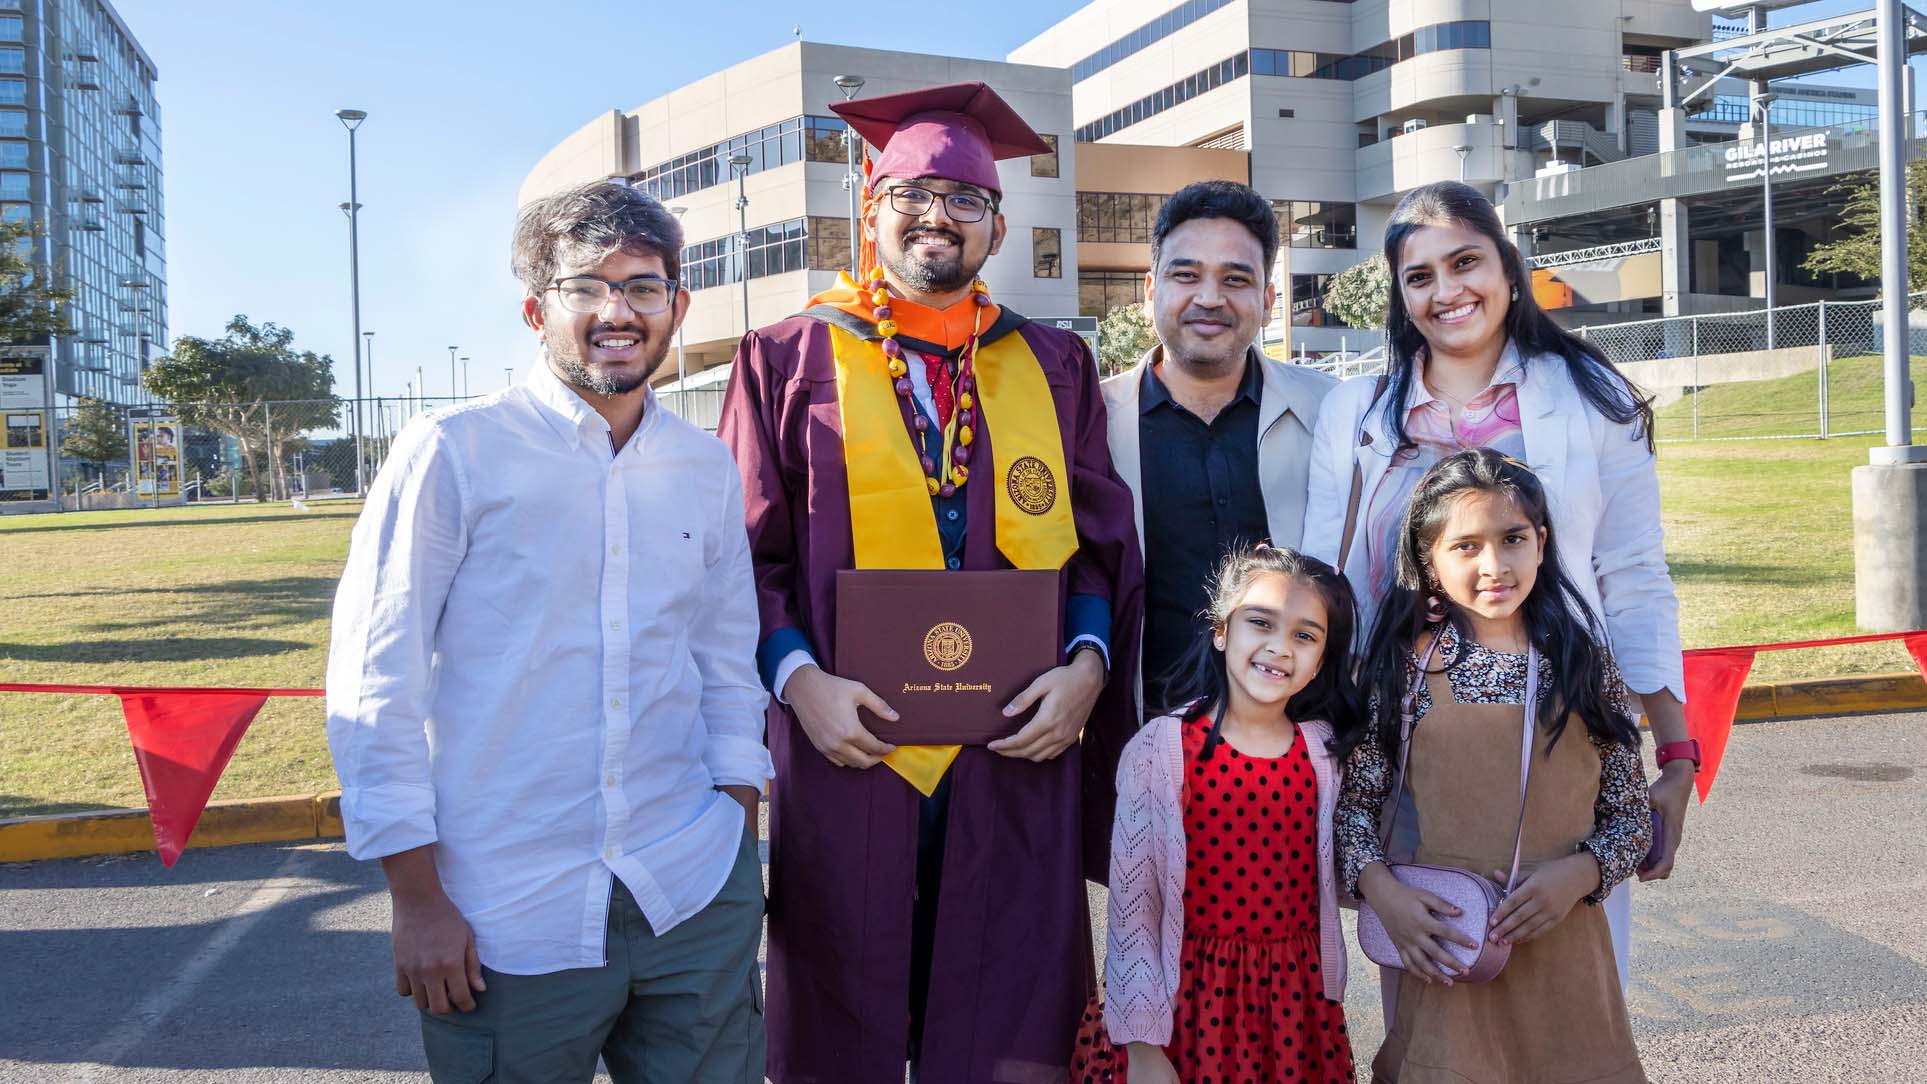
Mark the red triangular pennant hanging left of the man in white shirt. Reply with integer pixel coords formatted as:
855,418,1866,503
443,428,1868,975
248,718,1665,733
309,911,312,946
118,691,268,868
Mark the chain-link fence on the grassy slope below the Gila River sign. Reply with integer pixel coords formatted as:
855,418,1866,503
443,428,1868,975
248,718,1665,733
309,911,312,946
1574,295,1927,441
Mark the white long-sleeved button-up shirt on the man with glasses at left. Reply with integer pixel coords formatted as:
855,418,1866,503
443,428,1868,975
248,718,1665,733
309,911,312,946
328,362,773,974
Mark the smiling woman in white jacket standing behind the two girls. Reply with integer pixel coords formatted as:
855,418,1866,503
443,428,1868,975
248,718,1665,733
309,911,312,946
1303,183,1698,980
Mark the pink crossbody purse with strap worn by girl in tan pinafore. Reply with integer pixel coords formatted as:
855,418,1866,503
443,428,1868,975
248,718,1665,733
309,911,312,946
1359,635,1540,982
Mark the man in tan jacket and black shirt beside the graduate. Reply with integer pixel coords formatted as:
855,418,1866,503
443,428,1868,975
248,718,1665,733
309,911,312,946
1102,181,1337,716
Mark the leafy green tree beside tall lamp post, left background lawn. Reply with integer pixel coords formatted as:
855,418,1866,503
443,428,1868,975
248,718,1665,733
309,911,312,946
143,316,341,501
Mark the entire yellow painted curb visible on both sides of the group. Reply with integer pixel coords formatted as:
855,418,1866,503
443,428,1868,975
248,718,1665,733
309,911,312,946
0,672,1927,863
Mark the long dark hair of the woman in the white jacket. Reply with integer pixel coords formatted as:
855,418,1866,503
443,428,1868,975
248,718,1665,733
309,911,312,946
1380,181,1653,451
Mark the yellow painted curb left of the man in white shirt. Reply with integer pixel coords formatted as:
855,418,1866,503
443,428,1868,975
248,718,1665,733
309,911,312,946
0,791,341,863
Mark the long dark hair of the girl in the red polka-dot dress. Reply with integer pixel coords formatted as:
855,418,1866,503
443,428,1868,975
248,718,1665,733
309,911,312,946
1160,545,1362,761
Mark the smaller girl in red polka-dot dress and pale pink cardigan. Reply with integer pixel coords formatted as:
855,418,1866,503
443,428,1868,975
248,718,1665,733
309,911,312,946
1071,547,1357,1084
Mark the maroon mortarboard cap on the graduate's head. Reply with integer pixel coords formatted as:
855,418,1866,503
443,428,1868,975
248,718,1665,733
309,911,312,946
831,83,1050,198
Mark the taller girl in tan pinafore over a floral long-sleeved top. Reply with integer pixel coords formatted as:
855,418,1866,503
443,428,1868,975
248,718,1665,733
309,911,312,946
1335,449,1651,1084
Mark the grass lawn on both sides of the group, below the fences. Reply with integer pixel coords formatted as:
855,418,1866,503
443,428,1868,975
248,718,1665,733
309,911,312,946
0,421,1912,816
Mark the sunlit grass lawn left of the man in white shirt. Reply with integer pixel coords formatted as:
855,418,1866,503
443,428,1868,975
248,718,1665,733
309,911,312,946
0,501,360,816
